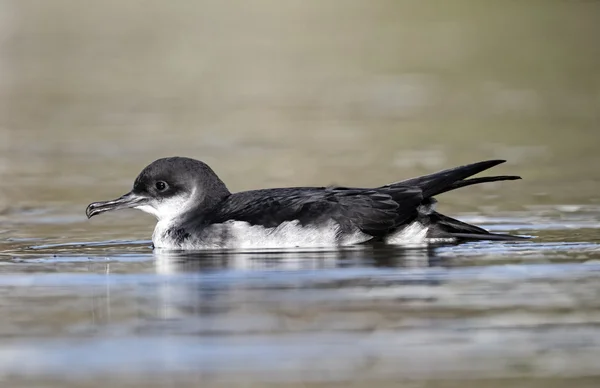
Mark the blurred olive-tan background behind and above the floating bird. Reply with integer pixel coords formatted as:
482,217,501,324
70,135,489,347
0,0,600,386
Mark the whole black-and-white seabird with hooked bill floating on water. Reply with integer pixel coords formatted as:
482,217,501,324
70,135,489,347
86,156,522,250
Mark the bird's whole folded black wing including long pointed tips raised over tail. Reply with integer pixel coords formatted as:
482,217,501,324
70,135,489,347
209,160,519,237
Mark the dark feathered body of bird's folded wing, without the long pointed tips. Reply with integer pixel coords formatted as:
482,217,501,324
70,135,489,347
210,187,422,236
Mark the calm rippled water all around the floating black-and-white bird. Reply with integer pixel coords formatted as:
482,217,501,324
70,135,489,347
0,0,600,388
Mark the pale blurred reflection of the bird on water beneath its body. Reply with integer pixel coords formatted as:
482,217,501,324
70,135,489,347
149,246,441,322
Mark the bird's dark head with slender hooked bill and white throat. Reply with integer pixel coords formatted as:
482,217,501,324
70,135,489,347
86,157,229,220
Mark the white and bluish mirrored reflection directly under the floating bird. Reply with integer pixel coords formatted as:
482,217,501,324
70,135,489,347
154,245,439,327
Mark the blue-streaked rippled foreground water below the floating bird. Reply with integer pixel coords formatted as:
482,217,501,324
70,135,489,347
0,242,600,385
